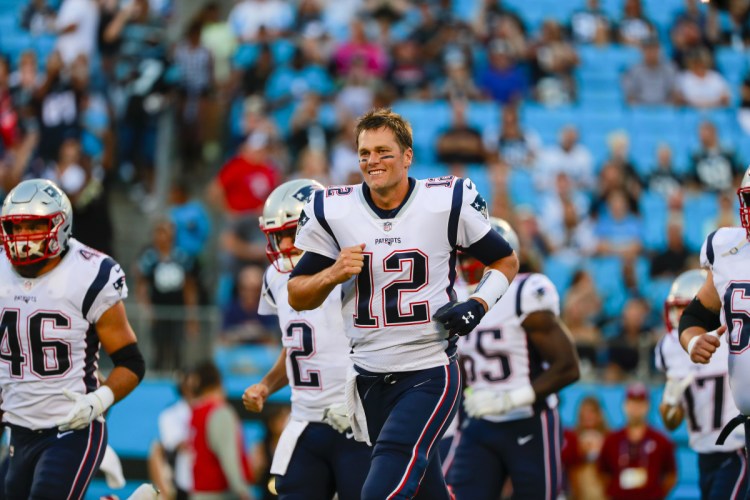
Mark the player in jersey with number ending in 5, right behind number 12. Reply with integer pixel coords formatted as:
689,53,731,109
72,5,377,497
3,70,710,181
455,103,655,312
448,217,579,500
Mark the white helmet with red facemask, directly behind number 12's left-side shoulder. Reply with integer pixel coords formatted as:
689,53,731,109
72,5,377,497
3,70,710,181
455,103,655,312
258,179,323,273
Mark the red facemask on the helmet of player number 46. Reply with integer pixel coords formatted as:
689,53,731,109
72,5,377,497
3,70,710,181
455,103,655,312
0,212,65,266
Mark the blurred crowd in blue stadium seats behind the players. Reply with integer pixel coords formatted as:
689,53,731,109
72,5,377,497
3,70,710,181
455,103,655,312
0,0,750,496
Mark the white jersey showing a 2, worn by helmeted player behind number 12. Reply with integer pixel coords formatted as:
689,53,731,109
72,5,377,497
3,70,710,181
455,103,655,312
258,266,351,422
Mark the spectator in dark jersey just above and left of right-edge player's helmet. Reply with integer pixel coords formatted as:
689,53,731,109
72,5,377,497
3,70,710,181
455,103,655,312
690,121,744,192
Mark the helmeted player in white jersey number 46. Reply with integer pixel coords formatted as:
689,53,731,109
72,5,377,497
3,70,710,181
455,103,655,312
0,179,145,499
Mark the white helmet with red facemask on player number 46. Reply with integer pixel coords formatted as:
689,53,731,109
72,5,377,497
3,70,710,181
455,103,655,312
0,179,73,266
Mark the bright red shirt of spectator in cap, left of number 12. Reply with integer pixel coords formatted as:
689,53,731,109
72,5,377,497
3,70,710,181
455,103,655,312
218,155,279,213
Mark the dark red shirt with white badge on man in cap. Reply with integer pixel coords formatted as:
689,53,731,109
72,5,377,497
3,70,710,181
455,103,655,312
599,427,677,500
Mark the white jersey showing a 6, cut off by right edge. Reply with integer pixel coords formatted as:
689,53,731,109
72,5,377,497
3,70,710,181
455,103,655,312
701,227,750,415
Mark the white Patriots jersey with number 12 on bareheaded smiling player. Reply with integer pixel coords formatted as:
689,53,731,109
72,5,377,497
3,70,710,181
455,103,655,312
296,176,490,373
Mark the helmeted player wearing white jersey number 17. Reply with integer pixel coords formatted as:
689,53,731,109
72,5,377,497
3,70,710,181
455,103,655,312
656,269,747,498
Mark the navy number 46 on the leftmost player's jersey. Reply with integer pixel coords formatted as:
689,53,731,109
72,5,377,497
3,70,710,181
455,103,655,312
0,309,70,378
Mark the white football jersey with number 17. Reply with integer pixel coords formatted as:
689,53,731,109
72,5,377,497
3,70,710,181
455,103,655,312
656,330,745,453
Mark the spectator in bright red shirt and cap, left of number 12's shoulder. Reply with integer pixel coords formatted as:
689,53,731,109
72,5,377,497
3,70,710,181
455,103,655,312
207,131,279,216
